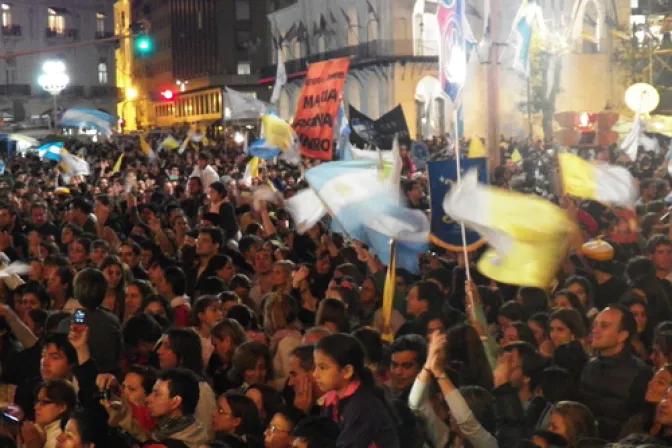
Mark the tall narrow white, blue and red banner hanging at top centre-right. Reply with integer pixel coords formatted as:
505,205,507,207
436,0,467,103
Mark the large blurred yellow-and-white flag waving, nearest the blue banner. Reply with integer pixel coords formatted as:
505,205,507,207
443,171,575,288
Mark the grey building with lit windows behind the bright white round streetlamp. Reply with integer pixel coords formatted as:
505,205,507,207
0,0,118,124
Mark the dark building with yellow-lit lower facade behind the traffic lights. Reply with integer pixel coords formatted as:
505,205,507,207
120,0,287,128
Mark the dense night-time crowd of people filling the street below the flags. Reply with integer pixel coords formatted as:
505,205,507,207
0,130,672,448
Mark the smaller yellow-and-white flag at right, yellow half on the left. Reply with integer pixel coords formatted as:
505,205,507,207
558,153,637,207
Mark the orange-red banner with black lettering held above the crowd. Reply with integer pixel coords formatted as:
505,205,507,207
292,58,350,160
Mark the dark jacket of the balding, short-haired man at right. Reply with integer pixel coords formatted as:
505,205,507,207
580,345,653,440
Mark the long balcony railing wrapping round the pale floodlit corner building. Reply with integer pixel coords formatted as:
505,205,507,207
261,39,439,78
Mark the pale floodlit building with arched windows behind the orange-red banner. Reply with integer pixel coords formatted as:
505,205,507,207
262,0,634,142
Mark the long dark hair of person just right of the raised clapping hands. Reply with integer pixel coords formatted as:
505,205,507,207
446,324,493,390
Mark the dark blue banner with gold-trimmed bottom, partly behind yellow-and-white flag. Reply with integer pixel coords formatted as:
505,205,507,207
427,158,488,251
